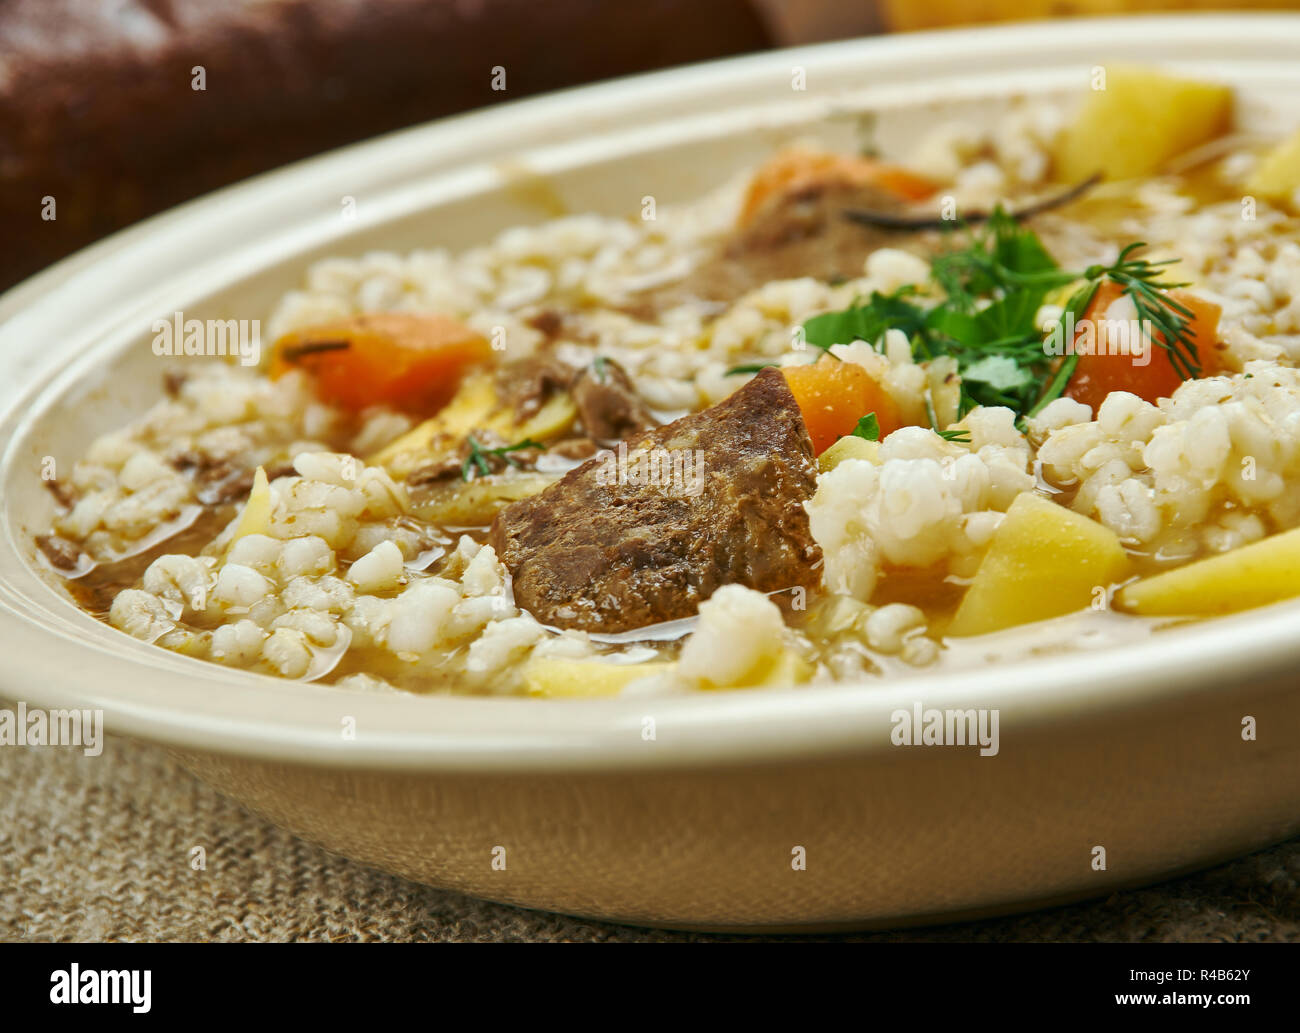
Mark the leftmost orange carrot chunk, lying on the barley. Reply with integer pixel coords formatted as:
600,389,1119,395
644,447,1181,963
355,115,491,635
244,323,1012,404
270,312,493,414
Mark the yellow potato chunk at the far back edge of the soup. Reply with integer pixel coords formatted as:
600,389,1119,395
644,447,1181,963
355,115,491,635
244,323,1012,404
1054,66,1232,183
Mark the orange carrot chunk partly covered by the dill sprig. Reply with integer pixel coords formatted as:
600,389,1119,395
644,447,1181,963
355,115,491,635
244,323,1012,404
1065,281,1223,414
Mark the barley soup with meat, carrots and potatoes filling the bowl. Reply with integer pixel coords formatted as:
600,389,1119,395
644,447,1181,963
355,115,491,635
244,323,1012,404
38,71,1300,696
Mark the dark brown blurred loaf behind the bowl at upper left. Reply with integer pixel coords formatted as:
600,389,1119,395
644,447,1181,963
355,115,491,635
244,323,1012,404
0,0,767,287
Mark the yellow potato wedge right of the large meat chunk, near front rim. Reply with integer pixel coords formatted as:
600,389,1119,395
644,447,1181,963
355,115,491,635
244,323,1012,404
948,494,1128,635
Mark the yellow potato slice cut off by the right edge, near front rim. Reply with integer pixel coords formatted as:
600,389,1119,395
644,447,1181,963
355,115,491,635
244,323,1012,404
1115,528,1300,617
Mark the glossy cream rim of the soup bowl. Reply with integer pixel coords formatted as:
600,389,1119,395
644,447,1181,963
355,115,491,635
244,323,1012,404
0,13,1300,773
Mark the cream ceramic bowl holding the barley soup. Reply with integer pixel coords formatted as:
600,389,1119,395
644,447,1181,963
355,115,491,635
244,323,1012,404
0,14,1300,928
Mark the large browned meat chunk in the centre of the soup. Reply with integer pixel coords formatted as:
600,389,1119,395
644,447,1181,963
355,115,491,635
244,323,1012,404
490,369,820,631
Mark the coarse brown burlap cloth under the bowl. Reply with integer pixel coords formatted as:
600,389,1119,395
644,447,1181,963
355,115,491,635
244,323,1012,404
0,739,1300,942
